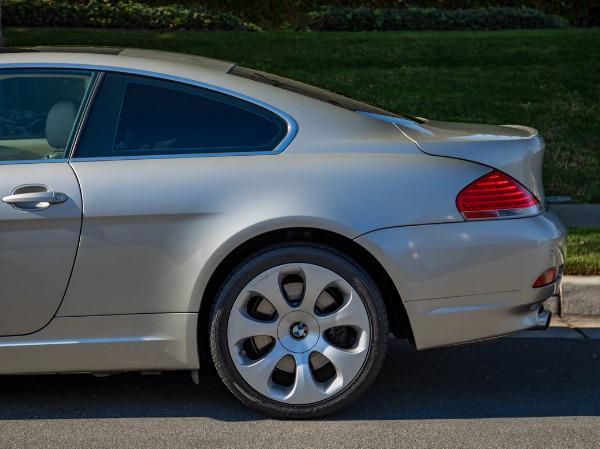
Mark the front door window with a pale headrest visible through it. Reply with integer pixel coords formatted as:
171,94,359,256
0,69,94,161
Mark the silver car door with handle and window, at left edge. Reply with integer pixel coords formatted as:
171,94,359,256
0,69,95,336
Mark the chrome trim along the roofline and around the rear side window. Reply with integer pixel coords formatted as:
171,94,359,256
0,63,298,162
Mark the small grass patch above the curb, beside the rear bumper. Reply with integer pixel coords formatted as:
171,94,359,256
565,227,600,275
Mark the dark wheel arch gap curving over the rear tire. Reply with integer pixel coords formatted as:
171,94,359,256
198,227,413,358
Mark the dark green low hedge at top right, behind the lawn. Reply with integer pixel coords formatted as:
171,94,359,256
308,6,569,31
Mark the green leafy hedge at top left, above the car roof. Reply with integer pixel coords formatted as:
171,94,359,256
2,0,260,31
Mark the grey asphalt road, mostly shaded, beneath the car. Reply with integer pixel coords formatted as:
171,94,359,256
0,338,600,449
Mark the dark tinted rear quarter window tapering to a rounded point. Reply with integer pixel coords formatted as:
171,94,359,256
76,73,287,157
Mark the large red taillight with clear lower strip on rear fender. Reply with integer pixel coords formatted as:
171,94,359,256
456,170,544,219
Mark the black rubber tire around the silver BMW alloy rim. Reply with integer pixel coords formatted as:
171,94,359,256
210,243,388,418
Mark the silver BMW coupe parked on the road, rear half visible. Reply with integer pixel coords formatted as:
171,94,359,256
0,47,566,418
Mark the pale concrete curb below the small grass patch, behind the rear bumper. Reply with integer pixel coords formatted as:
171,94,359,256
551,276,600,317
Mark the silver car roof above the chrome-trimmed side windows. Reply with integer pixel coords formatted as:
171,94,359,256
0,47,237,73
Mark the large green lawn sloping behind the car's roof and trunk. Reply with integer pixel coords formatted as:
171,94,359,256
4,28,600,202
